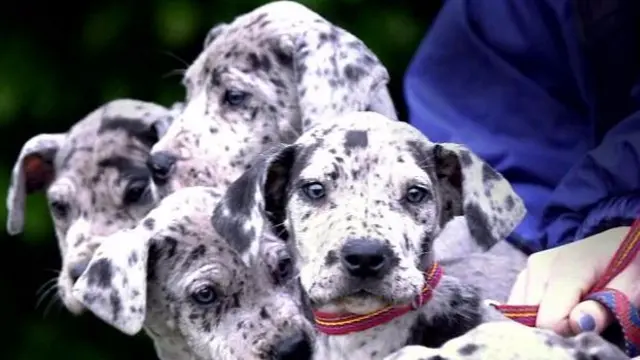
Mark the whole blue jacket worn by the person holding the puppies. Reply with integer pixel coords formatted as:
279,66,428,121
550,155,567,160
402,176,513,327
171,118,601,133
404,0,640,251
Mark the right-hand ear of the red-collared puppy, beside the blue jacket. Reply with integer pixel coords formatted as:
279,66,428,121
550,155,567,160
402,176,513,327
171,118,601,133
431,143,526,250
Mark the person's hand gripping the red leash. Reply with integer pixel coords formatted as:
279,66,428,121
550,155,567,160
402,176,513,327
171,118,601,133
507,226,640,336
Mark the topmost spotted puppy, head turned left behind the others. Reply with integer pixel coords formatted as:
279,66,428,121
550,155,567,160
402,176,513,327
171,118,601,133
150,1,396,198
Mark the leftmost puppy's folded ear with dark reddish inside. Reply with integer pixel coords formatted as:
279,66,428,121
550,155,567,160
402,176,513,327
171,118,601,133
7,134,66,235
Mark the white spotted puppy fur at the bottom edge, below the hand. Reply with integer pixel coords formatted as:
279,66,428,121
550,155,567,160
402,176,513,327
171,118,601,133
385,321,629,360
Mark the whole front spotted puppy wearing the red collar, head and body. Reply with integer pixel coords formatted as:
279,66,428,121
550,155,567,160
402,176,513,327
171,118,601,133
217,112,525,359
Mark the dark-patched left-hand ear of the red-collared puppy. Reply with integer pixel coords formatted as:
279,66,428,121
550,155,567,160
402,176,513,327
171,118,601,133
211,144,295,253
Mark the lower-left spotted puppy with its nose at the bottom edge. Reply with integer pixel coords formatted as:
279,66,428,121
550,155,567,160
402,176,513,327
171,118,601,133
73,187,314,360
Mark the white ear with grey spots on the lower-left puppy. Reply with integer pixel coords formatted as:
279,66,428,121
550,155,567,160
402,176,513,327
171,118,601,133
73,229,151,335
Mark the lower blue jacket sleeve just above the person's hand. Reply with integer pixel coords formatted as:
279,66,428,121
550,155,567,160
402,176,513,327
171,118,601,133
540,111,640,247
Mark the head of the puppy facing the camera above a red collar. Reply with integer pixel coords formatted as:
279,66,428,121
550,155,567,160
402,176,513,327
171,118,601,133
216,112,524,313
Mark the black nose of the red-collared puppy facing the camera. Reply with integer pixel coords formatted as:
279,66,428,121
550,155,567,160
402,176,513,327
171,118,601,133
341,239,393,278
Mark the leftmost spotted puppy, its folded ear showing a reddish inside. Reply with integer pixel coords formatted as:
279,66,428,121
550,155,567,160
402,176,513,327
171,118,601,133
7,99,179,314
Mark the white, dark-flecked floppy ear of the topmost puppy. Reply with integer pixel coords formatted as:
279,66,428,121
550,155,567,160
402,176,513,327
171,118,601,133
280,22,397,131
